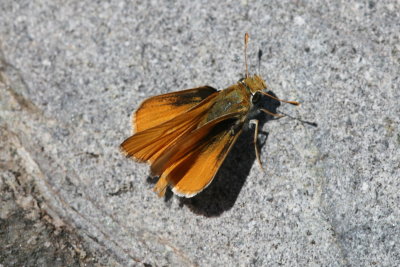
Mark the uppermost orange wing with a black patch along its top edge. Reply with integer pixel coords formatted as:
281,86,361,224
132,86,217,132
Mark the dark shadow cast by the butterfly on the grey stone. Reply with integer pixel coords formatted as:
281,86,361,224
147,91,280,217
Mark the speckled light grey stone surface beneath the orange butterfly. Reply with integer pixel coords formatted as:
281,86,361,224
0,0,400,266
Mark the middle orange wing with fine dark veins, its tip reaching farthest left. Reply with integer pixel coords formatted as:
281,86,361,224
121,93,218,162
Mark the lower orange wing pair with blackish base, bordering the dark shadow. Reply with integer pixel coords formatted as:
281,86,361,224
151,112,243,197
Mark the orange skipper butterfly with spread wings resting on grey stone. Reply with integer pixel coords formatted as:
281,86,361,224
120,33,299,197
